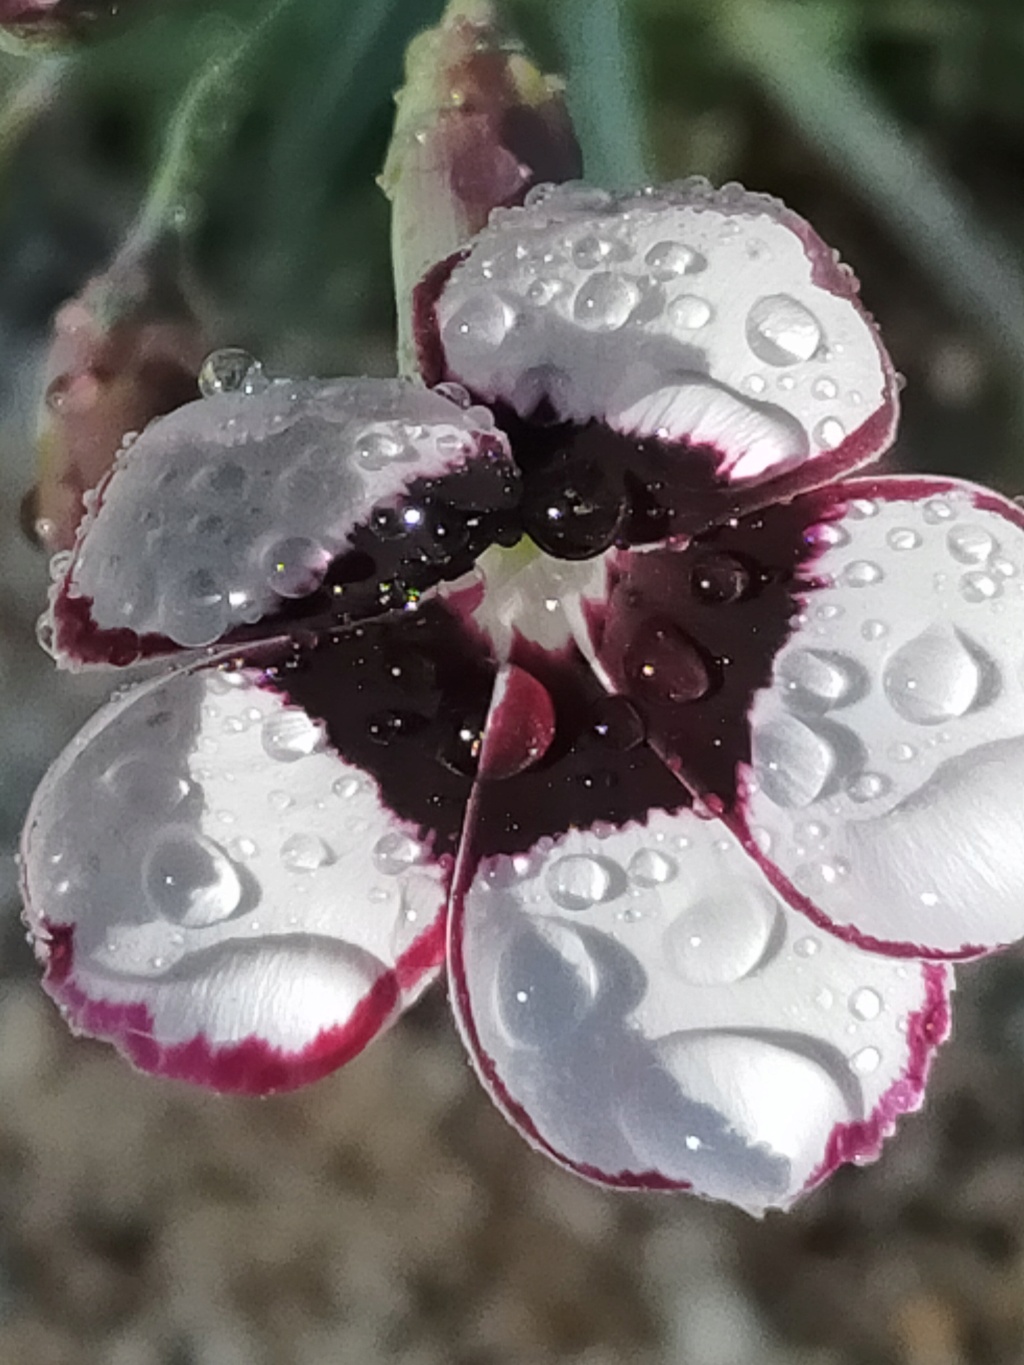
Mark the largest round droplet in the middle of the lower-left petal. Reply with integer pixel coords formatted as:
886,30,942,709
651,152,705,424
142,829,242,927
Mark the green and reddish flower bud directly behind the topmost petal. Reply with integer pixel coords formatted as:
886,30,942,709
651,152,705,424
381,0,582,373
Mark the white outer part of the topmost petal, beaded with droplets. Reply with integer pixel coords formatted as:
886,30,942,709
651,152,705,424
421,179,897,524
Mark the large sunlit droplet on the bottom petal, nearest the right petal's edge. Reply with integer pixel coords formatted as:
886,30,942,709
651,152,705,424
664,883,778,986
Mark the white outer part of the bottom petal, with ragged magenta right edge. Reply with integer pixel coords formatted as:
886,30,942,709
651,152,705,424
449,793,952,1213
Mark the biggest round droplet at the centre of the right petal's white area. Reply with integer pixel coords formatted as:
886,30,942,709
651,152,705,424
882,625,982,725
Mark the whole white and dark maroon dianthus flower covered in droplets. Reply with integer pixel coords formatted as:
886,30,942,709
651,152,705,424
23,182,1024,1211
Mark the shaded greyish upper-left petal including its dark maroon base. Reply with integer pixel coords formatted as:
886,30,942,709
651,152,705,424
51,379,517,665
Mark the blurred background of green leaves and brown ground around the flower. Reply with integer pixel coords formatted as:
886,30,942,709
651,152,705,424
0,0,1024,1365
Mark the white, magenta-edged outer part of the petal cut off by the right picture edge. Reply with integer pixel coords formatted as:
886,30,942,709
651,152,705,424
739,479,1024,957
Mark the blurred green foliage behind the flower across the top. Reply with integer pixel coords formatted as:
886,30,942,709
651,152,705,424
0,0,1024,491
